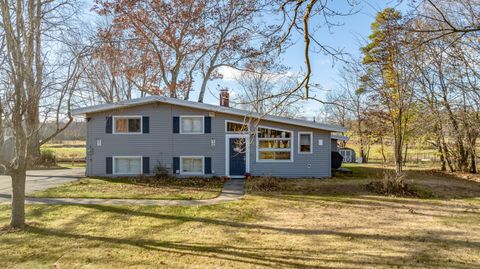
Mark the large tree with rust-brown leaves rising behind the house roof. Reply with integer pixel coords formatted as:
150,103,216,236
91,0,272,102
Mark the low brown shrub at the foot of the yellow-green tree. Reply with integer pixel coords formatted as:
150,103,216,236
366,172,420,197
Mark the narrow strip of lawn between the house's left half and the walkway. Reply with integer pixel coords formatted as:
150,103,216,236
29,178,224,200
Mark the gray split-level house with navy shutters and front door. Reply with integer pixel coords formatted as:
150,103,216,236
73,91,345,178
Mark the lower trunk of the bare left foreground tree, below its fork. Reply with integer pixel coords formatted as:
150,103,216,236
10,168,26,229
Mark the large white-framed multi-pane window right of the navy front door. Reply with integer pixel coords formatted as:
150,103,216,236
257,127,293,162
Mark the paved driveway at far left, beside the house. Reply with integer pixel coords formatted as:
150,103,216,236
0,168,85,204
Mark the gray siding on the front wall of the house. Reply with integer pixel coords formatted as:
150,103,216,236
87,103,331,178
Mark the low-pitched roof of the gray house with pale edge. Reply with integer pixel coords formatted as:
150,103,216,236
72,96,346,132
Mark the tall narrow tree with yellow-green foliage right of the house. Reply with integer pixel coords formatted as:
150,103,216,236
362,8,415,174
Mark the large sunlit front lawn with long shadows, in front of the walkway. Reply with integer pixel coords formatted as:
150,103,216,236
0,163,480,268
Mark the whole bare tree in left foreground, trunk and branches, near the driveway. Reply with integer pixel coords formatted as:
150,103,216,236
0,0,85,228
